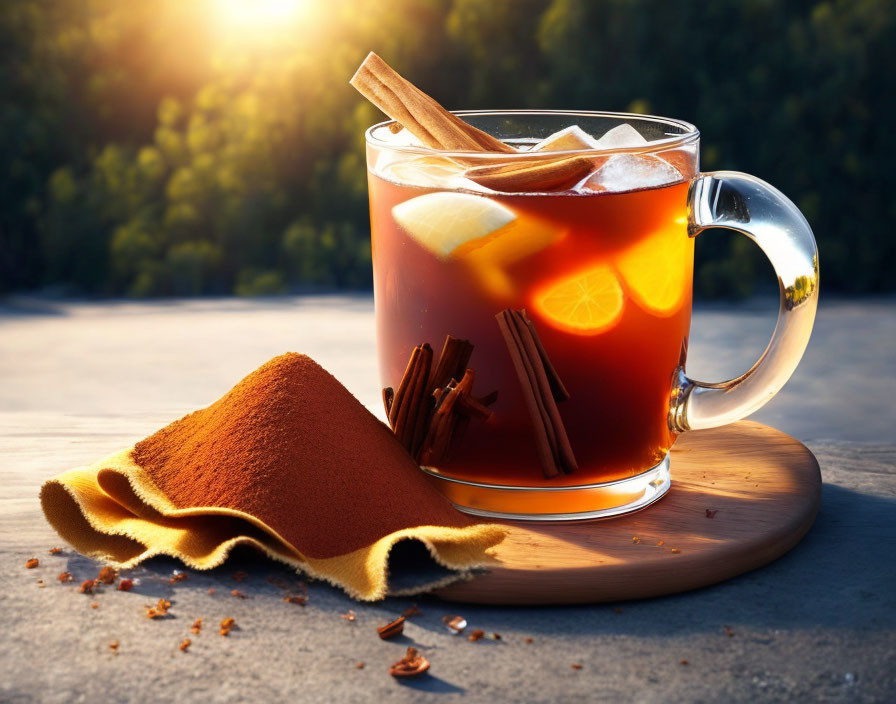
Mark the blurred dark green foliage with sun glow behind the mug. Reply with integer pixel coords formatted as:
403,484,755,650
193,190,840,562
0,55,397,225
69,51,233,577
0,0,896,296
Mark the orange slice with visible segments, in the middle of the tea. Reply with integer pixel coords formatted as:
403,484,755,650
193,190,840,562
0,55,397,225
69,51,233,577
533,264,623,335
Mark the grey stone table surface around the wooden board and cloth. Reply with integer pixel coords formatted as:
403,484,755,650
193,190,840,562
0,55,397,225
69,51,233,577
0,295,896,702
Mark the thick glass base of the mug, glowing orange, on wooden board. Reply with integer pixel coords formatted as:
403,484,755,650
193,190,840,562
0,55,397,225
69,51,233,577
421,454,671,521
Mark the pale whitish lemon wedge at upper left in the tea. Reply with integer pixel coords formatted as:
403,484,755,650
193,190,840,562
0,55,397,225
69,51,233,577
392,192,516,259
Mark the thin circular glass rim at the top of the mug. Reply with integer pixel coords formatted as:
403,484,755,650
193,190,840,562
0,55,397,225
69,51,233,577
364,110,700,158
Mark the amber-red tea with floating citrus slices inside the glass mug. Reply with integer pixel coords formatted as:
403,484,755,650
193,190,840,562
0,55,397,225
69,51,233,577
369,125,696,513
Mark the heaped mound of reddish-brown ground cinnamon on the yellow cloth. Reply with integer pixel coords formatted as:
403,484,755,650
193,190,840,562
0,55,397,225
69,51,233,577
133,353,474,558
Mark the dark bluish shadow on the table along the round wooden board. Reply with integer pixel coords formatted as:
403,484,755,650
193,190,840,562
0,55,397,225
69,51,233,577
414,484,896,636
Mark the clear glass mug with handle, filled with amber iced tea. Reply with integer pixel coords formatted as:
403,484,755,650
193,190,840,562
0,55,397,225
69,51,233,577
366,111,818,520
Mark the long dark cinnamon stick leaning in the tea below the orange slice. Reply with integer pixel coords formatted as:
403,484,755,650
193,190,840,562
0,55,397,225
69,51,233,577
495,308,578,477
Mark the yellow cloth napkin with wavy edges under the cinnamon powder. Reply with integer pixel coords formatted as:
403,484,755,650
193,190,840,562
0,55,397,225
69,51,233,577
40,450,504,601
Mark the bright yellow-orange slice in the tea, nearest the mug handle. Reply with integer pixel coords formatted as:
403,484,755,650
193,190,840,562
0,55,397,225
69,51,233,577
615,227,694,317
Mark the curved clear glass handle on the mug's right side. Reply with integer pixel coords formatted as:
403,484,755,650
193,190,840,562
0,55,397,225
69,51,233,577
669,171,818,433
